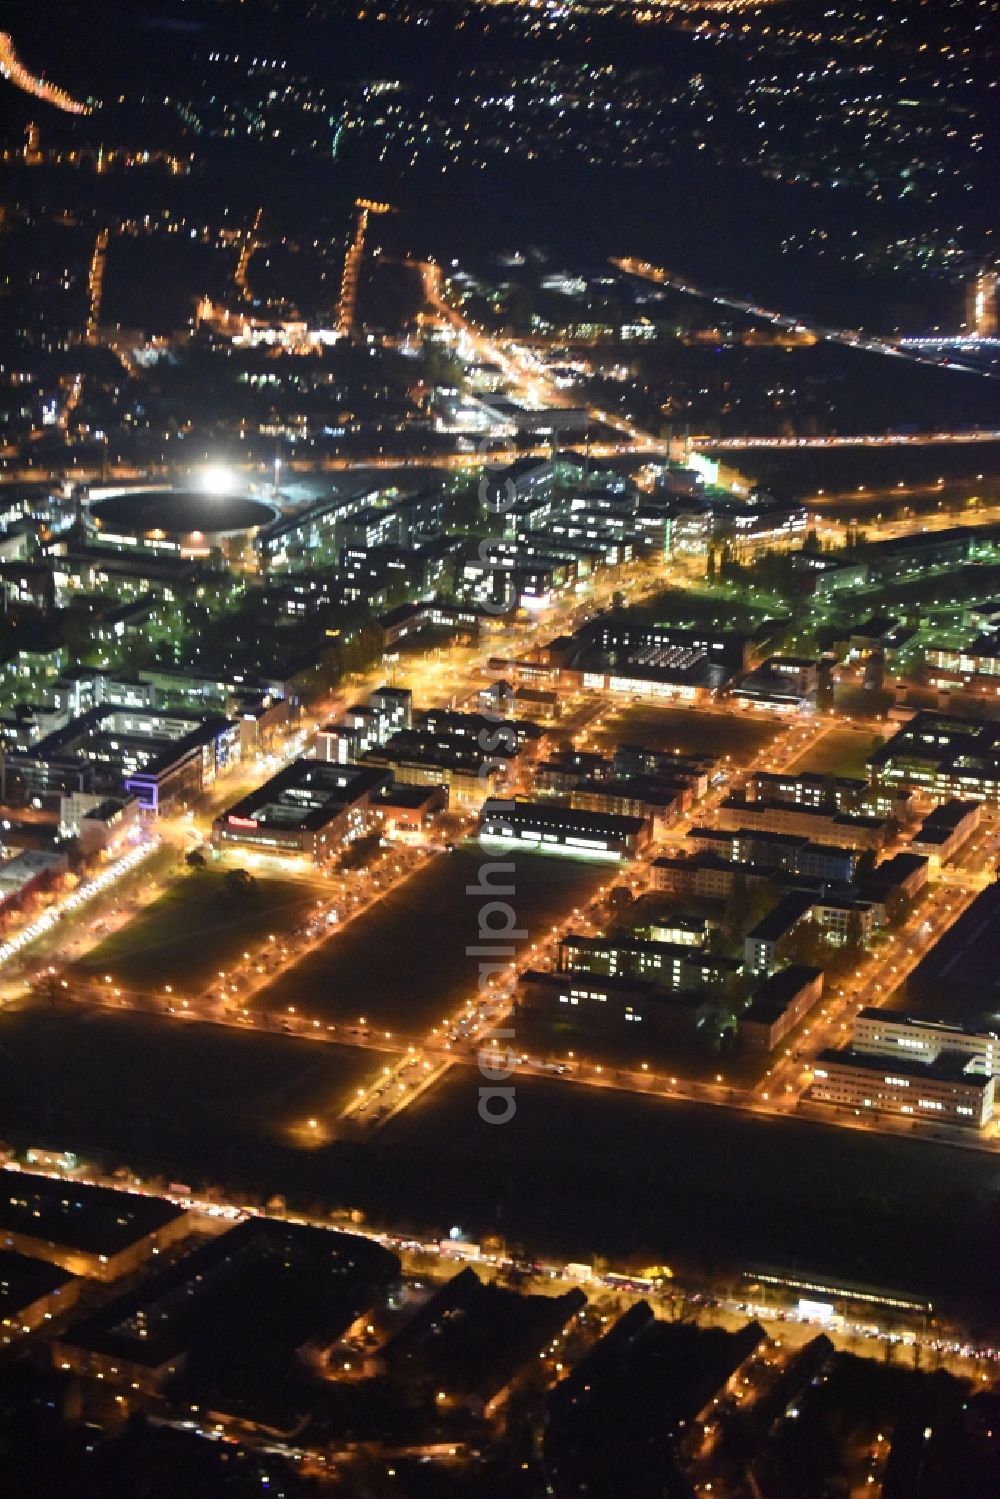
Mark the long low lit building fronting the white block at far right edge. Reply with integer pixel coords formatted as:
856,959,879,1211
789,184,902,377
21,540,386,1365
810,1048,994,1130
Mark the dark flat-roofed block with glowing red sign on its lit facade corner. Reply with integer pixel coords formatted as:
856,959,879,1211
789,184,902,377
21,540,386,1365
211,760,390,863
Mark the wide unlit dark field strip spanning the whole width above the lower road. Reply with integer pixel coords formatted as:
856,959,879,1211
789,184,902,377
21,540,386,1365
0,1009,1000,1322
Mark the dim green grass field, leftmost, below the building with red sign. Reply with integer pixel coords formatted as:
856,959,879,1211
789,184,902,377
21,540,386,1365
75,869,328,991
